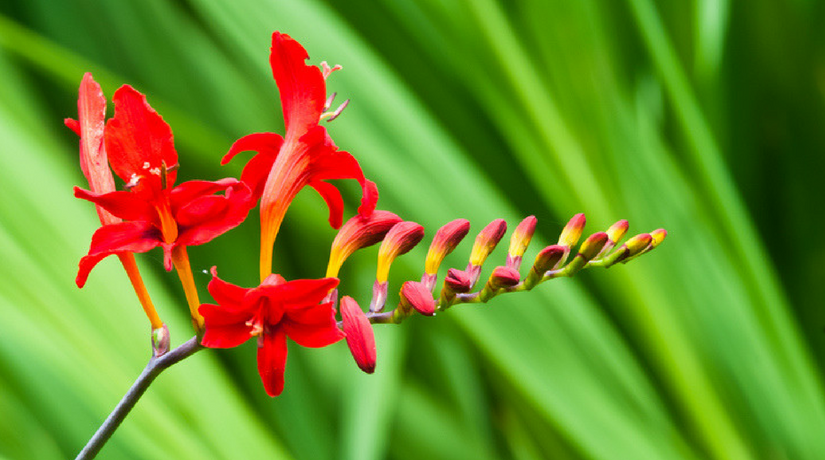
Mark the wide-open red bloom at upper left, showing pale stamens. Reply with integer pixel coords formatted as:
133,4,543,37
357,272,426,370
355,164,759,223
75,85,253,287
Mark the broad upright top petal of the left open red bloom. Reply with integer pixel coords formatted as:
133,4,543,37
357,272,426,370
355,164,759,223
106,85,178,193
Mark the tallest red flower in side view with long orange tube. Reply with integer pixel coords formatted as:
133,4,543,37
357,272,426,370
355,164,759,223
217,32,378,279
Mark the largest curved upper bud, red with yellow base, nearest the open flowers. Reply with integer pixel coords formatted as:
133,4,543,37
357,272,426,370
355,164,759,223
327,211,401,278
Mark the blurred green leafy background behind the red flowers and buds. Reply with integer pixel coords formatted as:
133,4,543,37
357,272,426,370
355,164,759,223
0,0,825,459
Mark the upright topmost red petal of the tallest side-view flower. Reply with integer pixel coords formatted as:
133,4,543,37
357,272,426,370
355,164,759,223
269,32,326,137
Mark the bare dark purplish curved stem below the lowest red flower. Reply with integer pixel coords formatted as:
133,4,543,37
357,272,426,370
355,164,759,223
75,336,204,460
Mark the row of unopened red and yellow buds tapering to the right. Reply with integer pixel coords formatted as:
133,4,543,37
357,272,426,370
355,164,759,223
326,211,667,373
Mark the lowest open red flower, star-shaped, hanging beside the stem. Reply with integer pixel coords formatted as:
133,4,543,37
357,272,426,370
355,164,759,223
200,267,344,396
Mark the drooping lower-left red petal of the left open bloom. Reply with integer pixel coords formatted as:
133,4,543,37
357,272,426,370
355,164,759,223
75,222,161,287
